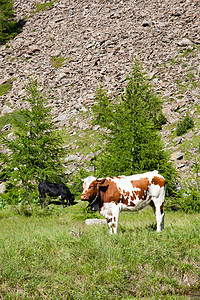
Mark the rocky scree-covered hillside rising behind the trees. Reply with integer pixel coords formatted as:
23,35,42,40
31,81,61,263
0,0,200,184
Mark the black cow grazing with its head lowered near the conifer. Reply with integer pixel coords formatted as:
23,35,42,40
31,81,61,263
38,181,74,208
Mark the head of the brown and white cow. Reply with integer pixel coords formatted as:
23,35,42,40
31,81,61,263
81,178,106,210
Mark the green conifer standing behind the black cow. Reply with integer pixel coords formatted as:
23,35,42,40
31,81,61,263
0,80,65,204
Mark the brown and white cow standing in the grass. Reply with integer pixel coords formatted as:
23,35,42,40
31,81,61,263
81,171,166,233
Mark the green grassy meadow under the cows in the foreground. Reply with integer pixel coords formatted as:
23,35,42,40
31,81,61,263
0,201,200,300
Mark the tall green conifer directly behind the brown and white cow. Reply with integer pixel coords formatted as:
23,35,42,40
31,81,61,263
93,63,175,191
